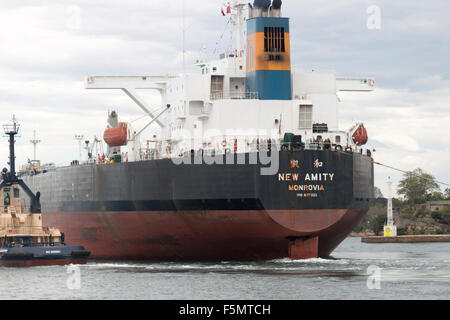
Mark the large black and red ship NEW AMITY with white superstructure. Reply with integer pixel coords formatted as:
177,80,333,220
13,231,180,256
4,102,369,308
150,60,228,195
22,0,374,261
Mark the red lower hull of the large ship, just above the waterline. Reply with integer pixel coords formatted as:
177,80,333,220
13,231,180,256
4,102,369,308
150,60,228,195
43,210,366,261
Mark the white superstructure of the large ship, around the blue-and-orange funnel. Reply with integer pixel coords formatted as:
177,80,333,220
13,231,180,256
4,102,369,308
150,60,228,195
86,0,374,158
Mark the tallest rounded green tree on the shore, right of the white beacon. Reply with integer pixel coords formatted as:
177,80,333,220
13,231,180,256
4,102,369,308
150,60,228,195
398,169,439,204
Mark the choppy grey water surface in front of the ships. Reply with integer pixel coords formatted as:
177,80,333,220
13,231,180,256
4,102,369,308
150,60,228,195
0,238,450,300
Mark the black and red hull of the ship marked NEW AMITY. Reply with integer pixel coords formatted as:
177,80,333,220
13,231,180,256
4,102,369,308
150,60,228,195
23,150,374,260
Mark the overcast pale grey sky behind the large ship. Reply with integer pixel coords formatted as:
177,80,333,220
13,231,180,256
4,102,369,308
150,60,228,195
0,0,450,198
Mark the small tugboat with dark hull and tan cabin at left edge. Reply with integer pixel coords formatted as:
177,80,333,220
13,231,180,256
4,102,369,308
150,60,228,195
0,117,90,267
